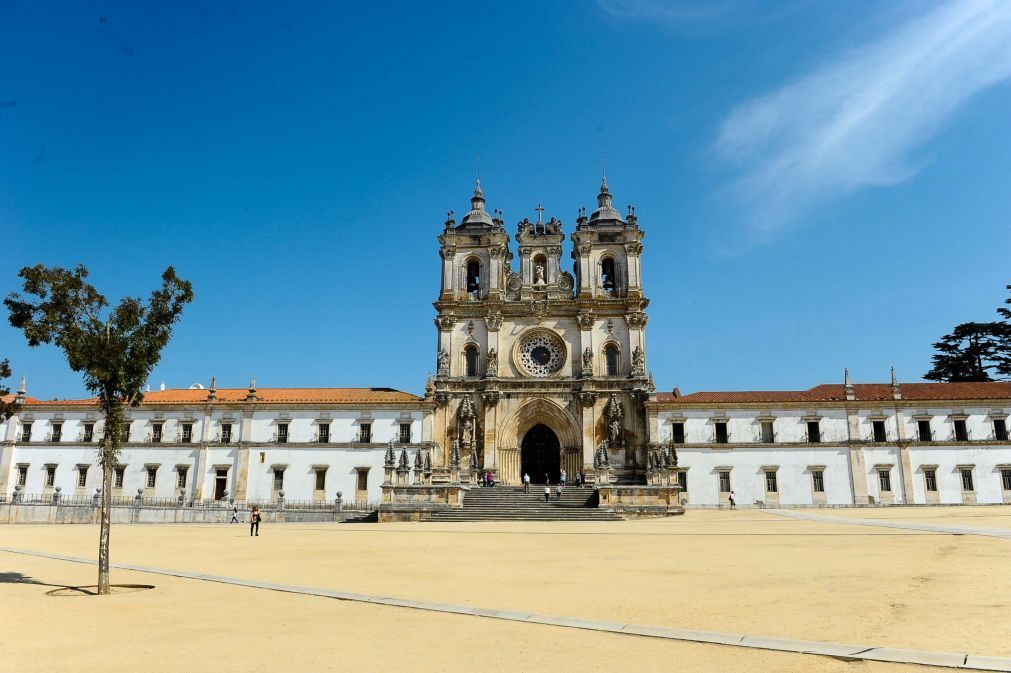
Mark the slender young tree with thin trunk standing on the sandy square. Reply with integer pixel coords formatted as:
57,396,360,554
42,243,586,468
4,265,193,594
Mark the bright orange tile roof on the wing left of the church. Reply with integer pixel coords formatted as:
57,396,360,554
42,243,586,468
20,388,423,406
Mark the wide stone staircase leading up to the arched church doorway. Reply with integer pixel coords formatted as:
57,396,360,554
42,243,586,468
430,484,624,521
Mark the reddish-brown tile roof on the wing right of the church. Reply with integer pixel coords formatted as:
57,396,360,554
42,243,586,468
656,381,1011,404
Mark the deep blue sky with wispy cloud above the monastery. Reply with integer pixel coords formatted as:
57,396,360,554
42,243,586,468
0,0,1011,398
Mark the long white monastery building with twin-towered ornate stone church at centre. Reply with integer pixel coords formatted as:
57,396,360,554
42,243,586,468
0,181,1011,507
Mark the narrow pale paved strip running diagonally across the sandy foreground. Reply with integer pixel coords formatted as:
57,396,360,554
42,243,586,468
0,541,1011,671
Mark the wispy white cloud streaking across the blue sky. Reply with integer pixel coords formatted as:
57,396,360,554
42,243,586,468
715,0,1011,238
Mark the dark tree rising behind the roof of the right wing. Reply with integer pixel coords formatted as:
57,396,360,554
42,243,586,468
923,322,1011,381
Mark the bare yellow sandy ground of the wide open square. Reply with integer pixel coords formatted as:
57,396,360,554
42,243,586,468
0,507,1011,672
